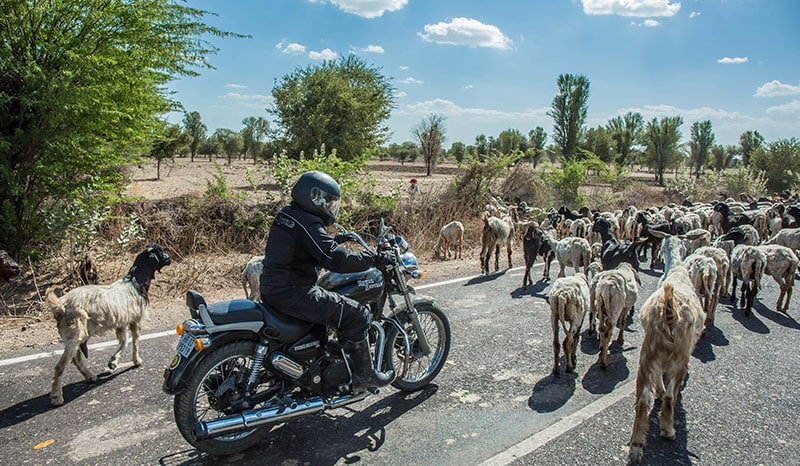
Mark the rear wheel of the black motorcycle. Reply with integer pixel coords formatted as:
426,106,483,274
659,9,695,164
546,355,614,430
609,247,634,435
173,341,269,456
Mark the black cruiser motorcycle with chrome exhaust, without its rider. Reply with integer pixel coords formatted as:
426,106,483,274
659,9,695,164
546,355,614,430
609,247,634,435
162,219,450,456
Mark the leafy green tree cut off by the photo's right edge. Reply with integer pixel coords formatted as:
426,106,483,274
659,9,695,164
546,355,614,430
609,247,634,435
750,138,800,193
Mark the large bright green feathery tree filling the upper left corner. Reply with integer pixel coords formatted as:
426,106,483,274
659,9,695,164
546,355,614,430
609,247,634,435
0,0,241,254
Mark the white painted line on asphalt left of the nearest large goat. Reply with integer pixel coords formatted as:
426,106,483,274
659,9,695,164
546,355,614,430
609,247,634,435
480,380,636,466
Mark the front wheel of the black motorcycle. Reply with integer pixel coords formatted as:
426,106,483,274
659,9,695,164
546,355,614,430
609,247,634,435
384,303,450,392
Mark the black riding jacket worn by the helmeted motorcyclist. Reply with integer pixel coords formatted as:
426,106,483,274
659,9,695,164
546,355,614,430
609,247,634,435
261,203,375,295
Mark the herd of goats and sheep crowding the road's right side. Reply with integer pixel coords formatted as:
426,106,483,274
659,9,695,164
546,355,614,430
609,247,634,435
435,198,800,463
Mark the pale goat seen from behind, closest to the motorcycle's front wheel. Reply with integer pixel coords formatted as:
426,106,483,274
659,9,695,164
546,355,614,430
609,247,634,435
550,273,589,377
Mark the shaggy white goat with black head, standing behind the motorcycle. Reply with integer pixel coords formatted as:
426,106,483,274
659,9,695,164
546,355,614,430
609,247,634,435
46,243,172,405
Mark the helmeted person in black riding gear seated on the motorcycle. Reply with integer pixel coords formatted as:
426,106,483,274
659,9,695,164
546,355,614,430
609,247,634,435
260,171,394,393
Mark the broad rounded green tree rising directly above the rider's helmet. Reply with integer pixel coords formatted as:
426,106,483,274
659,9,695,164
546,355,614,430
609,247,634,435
270,54,395,160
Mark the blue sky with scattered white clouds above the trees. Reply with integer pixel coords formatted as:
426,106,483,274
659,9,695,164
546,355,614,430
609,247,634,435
169,0,800,148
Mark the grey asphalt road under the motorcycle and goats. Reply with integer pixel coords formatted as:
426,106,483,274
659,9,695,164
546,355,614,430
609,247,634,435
0,264,800,466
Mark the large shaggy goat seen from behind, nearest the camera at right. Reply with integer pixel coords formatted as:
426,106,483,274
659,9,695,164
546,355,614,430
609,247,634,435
628,236,705,464
